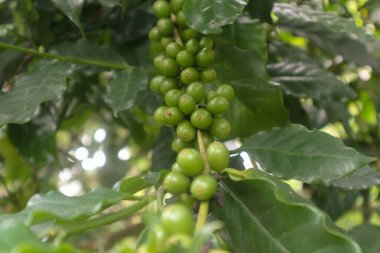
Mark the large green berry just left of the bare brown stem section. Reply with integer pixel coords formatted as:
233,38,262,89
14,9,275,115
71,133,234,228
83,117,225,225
177,148,205,176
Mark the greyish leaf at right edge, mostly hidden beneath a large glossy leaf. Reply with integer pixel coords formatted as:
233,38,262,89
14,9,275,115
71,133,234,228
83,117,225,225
329,166,380,190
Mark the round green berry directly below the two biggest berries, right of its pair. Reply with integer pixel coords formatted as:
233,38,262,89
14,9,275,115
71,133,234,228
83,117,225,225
190,175,218,201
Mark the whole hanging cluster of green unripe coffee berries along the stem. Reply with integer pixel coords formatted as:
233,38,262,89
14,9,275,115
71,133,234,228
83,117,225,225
140,0,234,252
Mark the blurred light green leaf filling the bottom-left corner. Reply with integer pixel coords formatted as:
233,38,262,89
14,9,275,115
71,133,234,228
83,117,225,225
0,222,83,253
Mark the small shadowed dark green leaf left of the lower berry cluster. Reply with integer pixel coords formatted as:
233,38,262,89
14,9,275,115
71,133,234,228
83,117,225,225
151,127,176,171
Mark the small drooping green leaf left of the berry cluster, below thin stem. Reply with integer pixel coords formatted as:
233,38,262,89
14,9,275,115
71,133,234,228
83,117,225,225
106,67,148,114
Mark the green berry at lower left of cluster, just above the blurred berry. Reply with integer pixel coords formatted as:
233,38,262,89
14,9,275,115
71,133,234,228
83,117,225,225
163,171,190,194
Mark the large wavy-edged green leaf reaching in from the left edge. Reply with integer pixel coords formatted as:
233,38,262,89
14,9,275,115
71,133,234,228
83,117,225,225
0,61,69,126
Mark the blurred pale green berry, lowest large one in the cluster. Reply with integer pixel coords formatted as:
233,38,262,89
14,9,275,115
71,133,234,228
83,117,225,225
161,203,195,235
